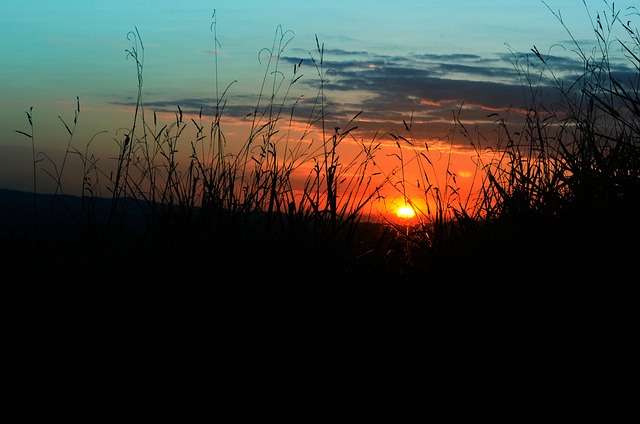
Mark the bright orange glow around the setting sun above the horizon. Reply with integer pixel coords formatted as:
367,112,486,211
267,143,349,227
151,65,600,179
27,96,490,223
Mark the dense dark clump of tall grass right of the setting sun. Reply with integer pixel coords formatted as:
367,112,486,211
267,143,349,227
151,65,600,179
420,0,640,288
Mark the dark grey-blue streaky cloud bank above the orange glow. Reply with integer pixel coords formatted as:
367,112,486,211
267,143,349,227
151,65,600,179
111,45,634,147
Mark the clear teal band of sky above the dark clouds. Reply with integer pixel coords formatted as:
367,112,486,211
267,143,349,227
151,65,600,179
0,0,596,104
